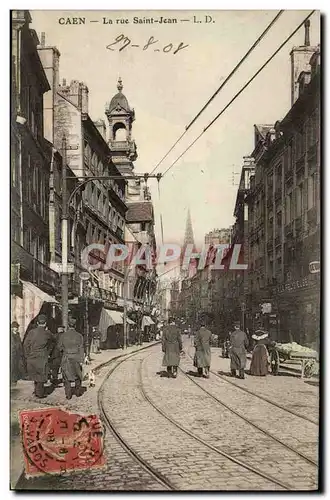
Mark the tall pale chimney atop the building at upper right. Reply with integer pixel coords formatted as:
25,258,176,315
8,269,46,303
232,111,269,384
290,19,317,106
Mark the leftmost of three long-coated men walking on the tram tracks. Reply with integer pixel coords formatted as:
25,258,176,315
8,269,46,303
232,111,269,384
162,318,182,378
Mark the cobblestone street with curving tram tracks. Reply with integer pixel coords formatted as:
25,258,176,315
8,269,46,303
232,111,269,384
13,339,318,491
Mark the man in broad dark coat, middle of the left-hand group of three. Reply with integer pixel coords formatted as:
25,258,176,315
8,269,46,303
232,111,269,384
23,314,52,398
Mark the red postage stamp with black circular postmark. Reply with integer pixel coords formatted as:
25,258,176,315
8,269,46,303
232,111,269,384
19,408,105,476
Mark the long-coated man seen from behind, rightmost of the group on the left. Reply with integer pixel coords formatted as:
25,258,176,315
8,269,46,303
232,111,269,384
58,317,84,399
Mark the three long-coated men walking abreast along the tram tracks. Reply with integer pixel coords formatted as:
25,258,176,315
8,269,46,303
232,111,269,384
162,318,249,379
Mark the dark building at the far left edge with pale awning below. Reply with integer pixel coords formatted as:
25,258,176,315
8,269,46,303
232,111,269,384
11,10,59,336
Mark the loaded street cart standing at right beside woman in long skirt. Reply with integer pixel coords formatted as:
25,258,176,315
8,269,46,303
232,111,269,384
269,342,318,379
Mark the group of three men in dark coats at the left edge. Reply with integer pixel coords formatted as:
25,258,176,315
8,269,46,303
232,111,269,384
11,314,84,399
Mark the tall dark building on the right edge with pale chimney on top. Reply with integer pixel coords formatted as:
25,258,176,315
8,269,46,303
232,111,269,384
246,22,320,348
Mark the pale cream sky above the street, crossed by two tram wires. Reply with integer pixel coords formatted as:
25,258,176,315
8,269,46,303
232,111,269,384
31,10,320,248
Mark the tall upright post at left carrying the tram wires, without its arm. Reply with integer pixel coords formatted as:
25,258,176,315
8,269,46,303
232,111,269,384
62,135,69,329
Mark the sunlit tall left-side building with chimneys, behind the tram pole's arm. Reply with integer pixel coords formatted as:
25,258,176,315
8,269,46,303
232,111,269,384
38,34,127,330
